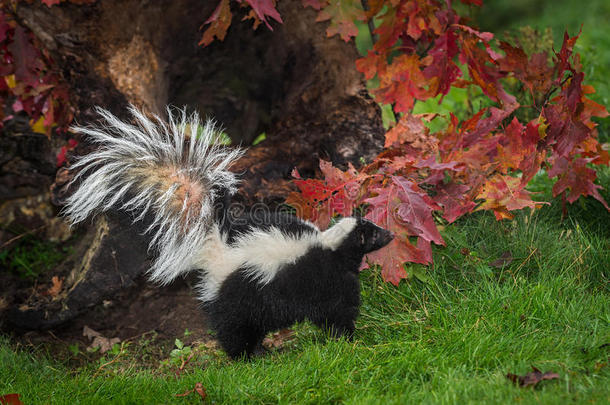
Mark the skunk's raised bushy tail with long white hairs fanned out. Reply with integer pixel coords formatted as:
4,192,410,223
63,106,243,284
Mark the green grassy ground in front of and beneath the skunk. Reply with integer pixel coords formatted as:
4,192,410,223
0,170,610,404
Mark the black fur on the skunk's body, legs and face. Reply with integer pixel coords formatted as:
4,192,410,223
206,215,393,358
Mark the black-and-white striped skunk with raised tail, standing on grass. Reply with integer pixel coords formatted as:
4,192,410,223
63,107,393,358
